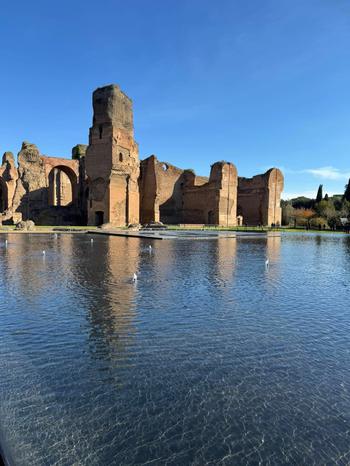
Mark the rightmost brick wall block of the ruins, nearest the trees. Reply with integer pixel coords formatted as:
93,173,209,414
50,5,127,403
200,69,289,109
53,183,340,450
238,168,284,226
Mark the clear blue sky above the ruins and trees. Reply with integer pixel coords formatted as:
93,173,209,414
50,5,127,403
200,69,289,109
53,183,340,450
0,0,350,197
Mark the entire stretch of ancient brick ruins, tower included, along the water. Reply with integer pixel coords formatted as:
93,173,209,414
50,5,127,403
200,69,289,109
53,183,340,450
0,85,283,226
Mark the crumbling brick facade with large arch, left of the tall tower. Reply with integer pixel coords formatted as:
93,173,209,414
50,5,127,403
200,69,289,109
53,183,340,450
0,141,84,225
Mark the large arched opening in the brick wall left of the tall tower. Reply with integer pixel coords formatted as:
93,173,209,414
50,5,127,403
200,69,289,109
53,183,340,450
49,165,77,207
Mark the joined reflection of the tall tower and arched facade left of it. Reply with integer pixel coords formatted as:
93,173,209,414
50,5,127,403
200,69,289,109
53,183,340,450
0,234,140,372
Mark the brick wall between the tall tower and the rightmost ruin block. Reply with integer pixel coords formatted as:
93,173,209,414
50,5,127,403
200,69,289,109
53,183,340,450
140,155,237,225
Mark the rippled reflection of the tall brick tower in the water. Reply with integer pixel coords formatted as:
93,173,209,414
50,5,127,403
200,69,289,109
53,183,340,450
75,237,140,362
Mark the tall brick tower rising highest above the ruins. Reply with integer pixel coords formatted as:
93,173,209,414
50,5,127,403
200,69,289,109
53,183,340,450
85,84,140,226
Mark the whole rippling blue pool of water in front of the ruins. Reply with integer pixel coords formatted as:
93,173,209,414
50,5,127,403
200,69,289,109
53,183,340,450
0,235,350,466
